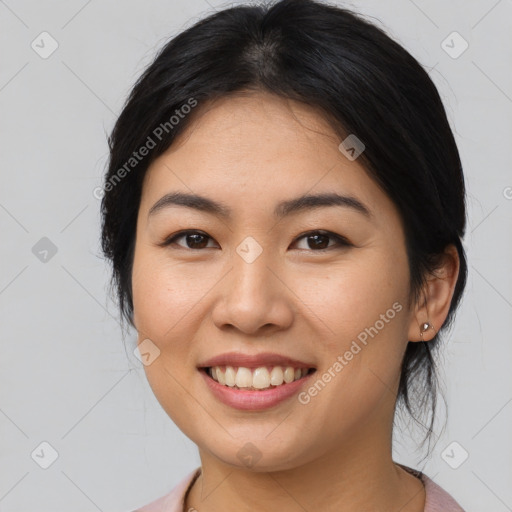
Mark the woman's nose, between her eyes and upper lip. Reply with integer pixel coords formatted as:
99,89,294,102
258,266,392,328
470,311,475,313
212,244,294,336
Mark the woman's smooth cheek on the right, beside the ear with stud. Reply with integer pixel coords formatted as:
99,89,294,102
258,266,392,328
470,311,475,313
292,251,408,420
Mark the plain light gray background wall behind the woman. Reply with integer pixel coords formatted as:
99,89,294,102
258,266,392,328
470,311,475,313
0,0,512,512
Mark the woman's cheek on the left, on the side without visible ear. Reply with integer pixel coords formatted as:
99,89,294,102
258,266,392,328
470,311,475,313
132,251,211,431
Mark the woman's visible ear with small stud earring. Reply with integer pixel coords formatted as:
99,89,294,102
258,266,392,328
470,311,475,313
408,244,460,341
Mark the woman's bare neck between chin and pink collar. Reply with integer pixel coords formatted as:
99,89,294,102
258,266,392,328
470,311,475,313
185,418,425,512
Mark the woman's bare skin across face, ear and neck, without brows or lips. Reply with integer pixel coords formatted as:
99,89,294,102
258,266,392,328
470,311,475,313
132,93,459,512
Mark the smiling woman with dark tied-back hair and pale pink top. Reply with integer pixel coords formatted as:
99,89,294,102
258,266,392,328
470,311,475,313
102,0,467,512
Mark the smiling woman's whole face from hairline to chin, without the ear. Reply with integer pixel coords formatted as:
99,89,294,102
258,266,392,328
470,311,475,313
132,94,420,470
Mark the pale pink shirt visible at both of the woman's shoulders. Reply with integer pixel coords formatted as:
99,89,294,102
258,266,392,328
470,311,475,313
135,464,464,512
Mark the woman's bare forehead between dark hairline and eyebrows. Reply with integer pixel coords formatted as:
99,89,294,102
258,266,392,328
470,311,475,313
141,93,396,228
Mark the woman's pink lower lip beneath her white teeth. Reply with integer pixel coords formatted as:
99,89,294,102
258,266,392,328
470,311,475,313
199,370,316,411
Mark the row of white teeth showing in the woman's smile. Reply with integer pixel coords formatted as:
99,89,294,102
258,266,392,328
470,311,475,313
208,366,308,389
